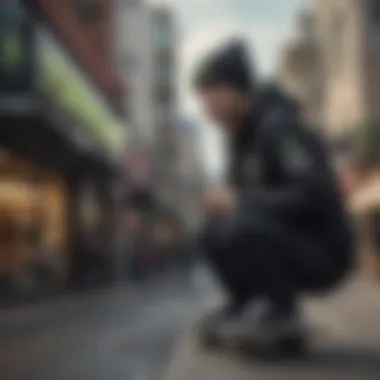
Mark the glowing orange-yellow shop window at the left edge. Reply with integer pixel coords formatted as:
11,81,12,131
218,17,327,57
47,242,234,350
0,150,66,282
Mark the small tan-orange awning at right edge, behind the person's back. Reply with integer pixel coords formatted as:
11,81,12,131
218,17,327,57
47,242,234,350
350,174,380,214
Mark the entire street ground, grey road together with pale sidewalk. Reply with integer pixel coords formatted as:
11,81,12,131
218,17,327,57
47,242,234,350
0,266,380,380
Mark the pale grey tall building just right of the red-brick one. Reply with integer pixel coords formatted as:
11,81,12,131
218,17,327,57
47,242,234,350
115,0,177,197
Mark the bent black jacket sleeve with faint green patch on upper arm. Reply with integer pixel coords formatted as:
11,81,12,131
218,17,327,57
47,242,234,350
236,122,334,220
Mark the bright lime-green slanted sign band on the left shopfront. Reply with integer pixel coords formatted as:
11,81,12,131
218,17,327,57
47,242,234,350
40,30,125,154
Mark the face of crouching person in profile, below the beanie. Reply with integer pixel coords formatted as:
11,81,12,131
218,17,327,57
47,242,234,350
198,84,249,132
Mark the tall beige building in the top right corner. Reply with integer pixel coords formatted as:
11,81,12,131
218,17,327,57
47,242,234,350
314,0,380,141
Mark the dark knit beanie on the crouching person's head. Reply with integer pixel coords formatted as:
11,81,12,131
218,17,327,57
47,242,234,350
193,40,255,92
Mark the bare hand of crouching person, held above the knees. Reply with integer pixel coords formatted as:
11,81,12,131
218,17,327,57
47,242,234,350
202,188,236,218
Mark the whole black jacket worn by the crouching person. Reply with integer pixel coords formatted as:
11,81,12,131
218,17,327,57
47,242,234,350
205,88,352,258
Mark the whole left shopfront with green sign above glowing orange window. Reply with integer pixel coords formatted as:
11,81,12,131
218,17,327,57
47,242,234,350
0,2,125,296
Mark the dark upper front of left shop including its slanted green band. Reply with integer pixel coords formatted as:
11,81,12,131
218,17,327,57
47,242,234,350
0,1,127,160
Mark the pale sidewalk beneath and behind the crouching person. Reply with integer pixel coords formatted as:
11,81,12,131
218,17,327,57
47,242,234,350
160,280,380,380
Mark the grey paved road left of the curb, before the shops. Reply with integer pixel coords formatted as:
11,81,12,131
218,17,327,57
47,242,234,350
0,270,215,380
